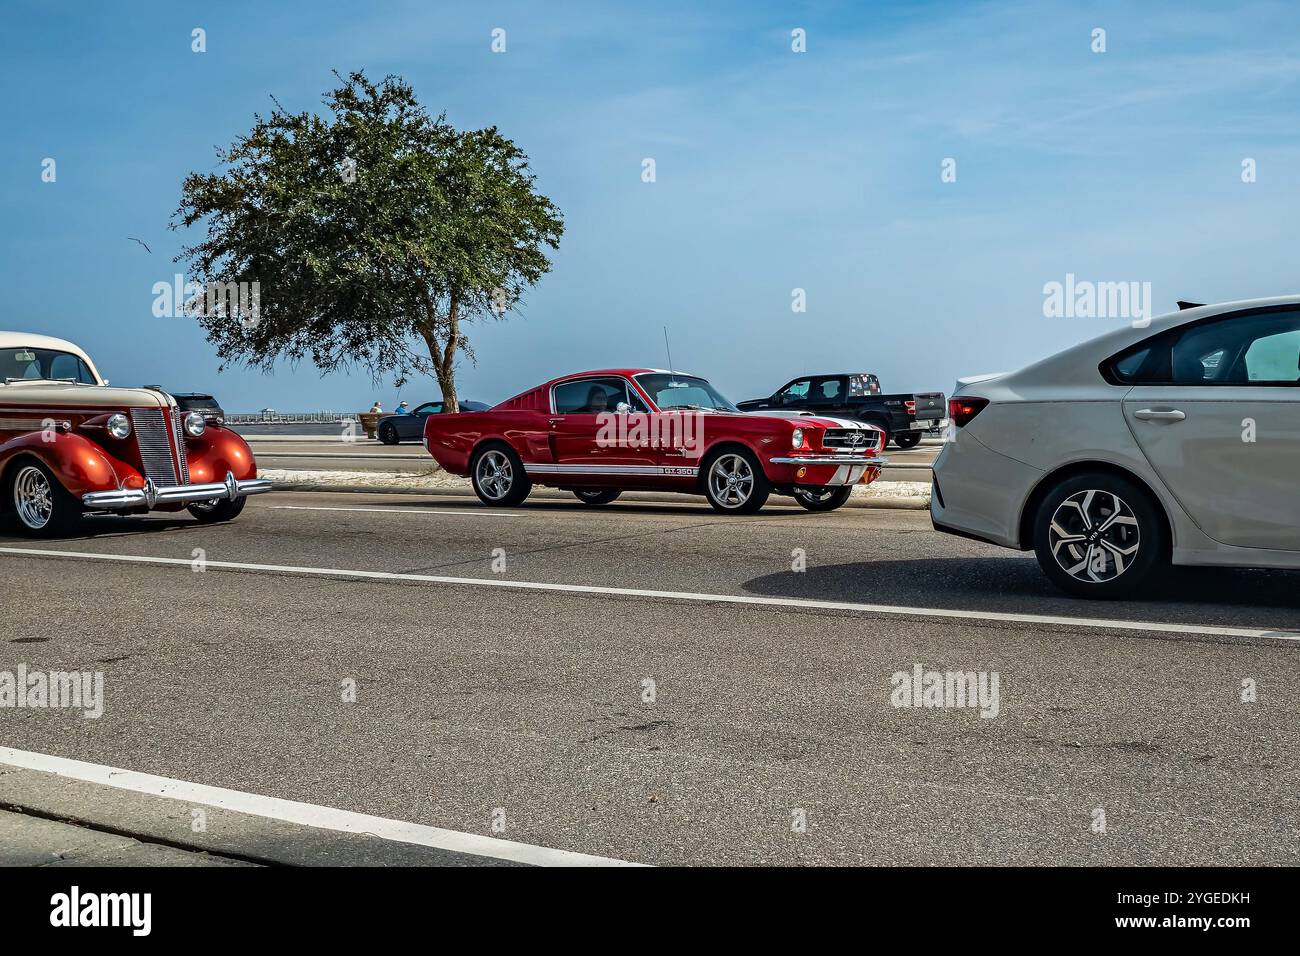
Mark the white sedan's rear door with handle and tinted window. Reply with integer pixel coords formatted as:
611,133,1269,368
1117,311,1300,551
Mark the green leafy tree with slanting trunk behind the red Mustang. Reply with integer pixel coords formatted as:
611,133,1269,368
172,72,564,411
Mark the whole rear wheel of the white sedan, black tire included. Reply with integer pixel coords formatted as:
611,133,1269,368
1034,472,1169,600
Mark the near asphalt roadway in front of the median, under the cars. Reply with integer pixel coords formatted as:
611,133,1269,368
0,493,1300,864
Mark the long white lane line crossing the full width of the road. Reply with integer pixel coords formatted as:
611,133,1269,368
0,548,1300,641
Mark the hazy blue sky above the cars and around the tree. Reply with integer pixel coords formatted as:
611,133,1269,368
0,0,1300,411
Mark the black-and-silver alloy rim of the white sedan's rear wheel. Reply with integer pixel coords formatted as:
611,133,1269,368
1048,489,1141,584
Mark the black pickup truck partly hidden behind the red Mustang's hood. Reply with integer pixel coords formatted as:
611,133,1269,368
737,372,948,449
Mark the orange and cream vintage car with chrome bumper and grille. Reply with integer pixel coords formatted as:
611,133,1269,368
0,332,270,536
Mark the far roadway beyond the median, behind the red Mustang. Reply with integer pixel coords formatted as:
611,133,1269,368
244,434,941,481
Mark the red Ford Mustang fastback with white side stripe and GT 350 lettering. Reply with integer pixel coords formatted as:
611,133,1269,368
424,368,885,514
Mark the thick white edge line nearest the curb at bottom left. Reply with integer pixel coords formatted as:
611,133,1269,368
0,747,641,866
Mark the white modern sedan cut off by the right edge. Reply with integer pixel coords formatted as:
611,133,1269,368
931,295,1300,597
